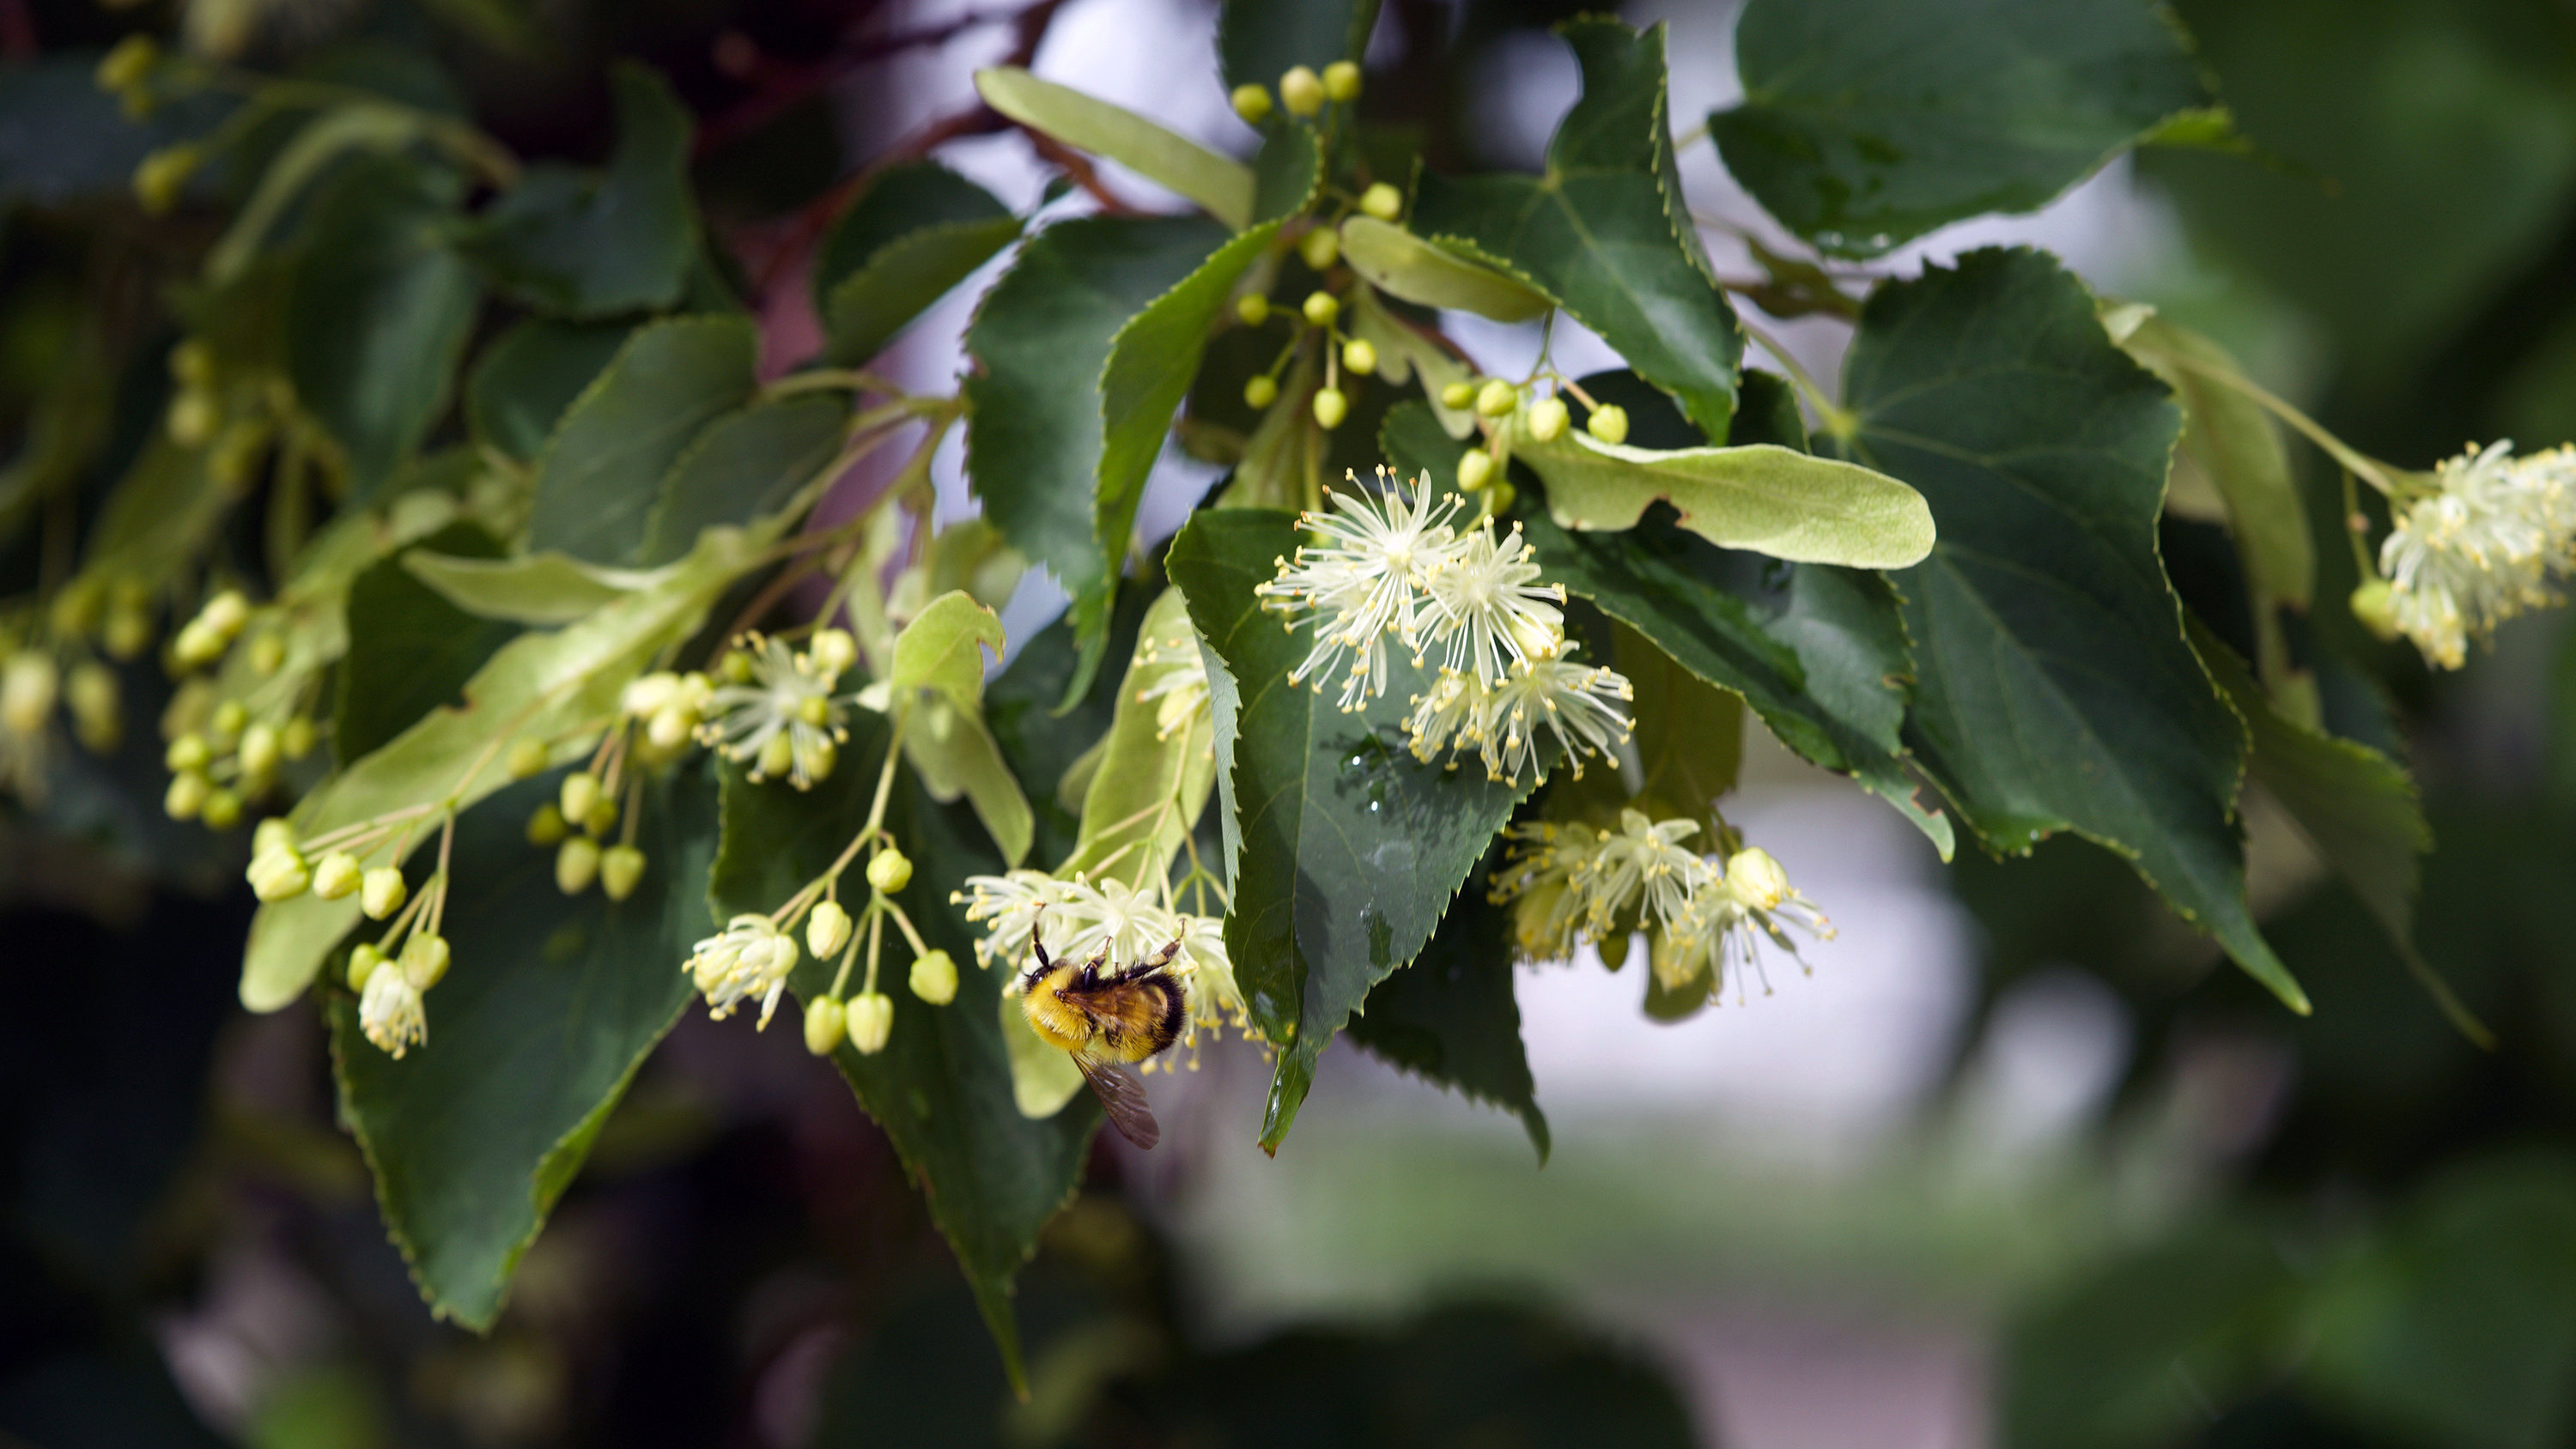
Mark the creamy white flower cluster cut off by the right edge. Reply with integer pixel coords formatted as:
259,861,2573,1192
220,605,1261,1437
2380,443,2576,670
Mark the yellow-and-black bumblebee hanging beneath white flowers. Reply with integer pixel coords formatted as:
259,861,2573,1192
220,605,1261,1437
1020,926,1190,1148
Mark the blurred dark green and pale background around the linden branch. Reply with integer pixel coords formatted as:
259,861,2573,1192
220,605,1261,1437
0,0,2576,1449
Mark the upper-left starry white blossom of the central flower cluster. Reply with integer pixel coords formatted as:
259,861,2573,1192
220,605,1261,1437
1255,469,1461,711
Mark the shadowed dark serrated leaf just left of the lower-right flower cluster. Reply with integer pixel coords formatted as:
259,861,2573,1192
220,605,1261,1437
1347,882,1548,1163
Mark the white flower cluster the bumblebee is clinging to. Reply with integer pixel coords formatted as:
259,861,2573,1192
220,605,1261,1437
951,870,1252,1047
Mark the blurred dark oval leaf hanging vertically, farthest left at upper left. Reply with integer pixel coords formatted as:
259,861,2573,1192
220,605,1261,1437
286,157,479,497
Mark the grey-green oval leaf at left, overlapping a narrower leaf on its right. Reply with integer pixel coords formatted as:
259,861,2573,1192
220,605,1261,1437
528,317,760,567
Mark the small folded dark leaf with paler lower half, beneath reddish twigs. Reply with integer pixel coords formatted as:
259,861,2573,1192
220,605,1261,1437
814,162,1020,368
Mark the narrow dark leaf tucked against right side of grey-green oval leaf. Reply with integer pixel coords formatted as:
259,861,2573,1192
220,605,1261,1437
636,394,850,567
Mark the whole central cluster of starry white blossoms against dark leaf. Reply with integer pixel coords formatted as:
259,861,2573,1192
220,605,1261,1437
1257,469,1633,779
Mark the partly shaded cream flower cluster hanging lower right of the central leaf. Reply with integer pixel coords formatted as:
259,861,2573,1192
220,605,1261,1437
1494,810,1834,993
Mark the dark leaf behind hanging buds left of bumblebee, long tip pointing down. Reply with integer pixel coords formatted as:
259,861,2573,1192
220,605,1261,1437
708,741,1100,1382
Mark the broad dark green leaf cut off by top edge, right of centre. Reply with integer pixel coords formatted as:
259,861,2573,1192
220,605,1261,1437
1708,0,2210,258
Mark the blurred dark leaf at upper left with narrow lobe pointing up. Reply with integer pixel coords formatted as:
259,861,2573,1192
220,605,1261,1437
461,62,698,317
